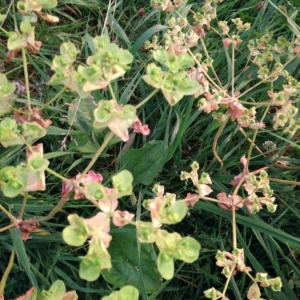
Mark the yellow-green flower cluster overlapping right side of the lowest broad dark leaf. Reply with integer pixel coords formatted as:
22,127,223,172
136,184,200,279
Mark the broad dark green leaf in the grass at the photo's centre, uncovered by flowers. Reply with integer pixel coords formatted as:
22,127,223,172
120,141,165,185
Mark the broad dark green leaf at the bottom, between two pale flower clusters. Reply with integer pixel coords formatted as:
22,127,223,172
102,225,161,293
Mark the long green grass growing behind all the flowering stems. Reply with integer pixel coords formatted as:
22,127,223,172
0,0,300,300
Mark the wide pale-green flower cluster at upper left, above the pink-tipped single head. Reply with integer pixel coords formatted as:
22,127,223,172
48,35,133,98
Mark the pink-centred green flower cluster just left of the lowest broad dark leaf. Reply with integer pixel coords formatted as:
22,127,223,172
62,170,134,281
